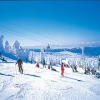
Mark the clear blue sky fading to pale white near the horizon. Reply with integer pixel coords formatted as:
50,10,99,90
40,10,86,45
0,0,100,46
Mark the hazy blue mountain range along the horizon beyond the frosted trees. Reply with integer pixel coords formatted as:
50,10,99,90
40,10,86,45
23,45,100,56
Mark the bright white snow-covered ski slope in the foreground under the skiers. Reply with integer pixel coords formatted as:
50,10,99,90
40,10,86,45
0,59,100,100
